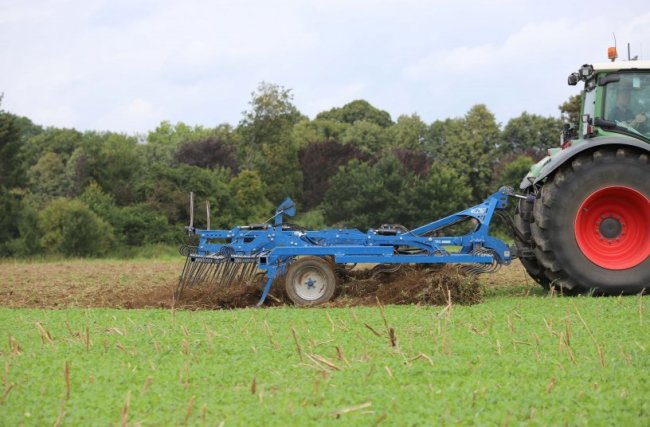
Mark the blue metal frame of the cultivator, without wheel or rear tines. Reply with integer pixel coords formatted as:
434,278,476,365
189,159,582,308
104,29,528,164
188,187,512,305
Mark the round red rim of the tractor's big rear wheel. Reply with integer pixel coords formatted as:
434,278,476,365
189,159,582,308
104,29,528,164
575,187,650,270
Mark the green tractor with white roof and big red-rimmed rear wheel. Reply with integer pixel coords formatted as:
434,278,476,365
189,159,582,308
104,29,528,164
515,56,650,294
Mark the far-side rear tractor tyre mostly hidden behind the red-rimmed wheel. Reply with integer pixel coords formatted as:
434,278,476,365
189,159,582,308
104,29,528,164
514,199,550,289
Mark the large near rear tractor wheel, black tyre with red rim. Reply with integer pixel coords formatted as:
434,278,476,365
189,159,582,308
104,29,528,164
530,148,650,294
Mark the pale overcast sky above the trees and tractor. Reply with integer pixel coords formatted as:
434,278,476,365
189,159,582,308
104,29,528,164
0,0,650,133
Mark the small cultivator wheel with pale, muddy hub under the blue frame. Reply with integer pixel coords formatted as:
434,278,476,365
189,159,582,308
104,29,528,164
285,256,337,306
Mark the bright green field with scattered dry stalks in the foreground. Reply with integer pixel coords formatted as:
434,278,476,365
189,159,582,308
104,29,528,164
0,260,650,426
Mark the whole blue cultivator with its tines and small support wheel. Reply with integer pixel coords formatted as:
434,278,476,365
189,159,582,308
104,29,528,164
175,188,512,305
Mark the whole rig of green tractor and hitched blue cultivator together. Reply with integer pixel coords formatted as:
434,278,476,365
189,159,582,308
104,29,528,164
175,50,650,306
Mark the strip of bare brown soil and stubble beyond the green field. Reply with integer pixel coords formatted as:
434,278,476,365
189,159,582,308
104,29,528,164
0,260,530,309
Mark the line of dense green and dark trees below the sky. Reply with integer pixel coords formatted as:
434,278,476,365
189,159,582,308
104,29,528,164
0,83,579,257
